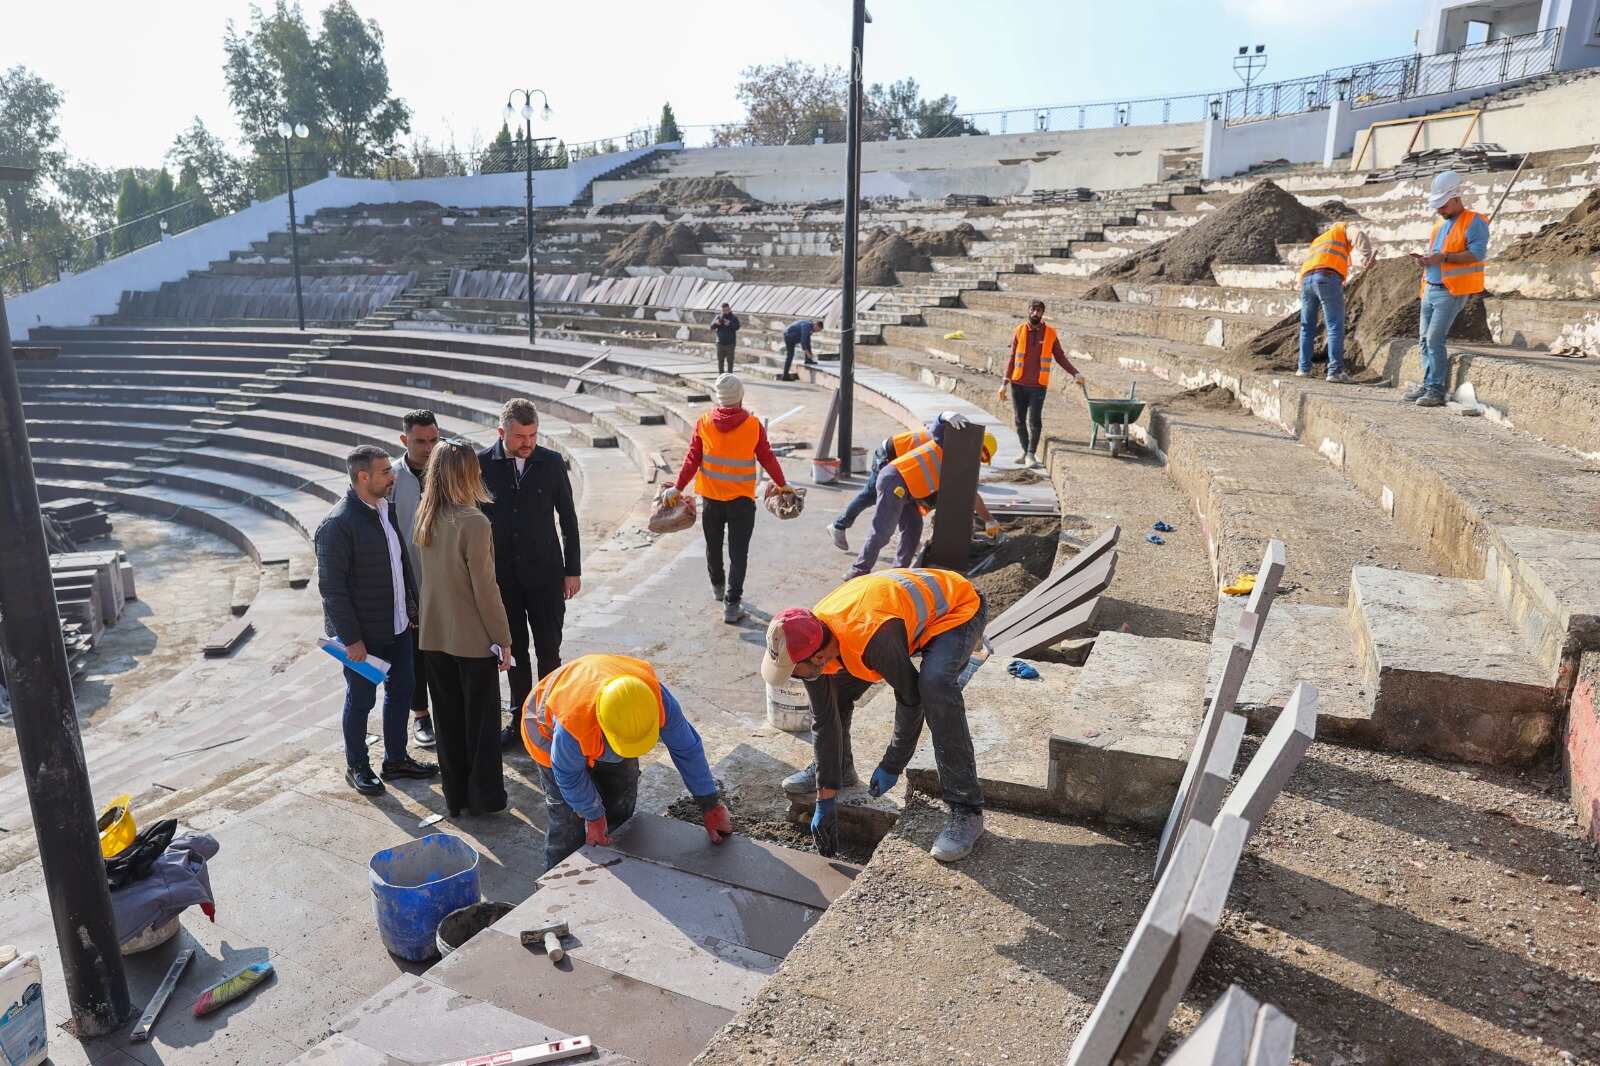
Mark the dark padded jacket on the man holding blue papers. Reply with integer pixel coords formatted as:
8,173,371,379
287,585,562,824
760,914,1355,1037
312,490,416,645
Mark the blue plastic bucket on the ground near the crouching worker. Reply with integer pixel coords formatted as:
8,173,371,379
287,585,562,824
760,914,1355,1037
368,832,478,962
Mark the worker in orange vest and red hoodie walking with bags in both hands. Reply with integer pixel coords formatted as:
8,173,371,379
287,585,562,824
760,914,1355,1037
661,375,794,626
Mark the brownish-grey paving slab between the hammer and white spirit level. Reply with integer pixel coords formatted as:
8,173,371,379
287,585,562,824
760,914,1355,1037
427,928,733,1066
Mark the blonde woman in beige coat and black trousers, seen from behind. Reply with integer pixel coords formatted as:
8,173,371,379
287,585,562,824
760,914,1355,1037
413,439,510,818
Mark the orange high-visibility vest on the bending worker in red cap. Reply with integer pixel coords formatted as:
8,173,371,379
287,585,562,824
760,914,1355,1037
811,568,979,682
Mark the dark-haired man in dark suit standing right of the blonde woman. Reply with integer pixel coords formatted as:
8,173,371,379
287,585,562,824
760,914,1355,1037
478,399,582,746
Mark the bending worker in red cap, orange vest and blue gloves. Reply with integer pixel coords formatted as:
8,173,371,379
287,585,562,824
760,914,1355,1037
762,570,987,863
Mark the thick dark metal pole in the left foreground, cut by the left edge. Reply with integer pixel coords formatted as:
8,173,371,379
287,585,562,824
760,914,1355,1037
0,294,131,1037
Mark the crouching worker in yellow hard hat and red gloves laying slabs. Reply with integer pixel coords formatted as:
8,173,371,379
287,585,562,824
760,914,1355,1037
522,655,733,869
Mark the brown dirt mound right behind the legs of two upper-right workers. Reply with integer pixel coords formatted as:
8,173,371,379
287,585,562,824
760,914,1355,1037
1229,258,1494,370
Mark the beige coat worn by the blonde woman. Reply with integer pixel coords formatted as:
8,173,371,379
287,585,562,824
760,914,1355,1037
416,507,510,659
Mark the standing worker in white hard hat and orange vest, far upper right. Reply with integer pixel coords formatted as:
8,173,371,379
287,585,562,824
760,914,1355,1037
1400,170,1490,407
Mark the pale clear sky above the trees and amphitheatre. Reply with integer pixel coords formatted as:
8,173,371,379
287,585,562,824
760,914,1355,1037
12,0,1422,166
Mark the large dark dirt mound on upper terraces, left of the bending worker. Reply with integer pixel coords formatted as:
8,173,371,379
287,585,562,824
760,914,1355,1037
1094,181,1328,285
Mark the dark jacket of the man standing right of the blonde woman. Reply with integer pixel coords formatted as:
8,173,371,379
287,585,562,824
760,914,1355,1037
478,440,582,589
